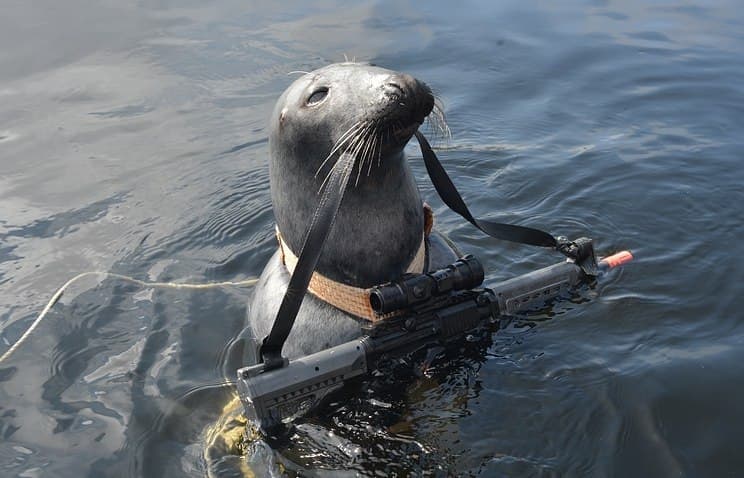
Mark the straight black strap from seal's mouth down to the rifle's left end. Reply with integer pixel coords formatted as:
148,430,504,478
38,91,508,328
261,153,354,371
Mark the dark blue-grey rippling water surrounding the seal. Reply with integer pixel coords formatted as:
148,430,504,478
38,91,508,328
0,0,744,477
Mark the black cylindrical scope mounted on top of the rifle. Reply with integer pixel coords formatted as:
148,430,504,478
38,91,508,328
369,254,483,314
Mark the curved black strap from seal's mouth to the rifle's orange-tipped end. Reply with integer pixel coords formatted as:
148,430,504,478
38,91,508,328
416,131,563,249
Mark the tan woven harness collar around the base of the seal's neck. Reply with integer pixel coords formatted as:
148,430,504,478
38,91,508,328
276,203,434,322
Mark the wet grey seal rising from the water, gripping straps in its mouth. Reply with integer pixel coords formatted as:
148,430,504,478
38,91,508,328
248,62,460,358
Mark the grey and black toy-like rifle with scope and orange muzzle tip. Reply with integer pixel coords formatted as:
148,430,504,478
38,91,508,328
238,238,632,431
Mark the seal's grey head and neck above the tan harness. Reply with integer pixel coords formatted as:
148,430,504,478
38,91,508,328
269,63,434,287
